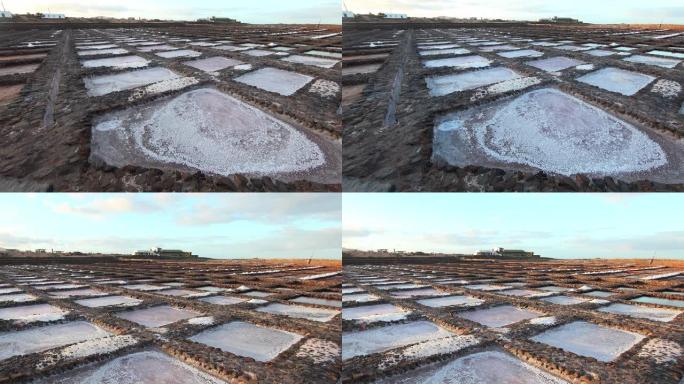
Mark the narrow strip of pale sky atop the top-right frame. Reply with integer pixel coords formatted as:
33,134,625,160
344,0,684,24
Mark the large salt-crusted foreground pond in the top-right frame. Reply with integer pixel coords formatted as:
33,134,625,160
433,88,668,177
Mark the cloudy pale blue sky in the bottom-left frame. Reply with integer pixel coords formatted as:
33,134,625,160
0,193,342,258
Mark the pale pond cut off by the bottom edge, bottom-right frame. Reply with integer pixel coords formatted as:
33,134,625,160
376,350,569,384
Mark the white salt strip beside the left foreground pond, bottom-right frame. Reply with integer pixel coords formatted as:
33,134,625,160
379,335,480,370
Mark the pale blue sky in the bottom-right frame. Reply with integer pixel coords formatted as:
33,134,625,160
342,193,684,259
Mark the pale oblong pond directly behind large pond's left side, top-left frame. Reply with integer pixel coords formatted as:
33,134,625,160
84,67,180,96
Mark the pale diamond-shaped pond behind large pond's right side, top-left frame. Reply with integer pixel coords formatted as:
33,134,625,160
235,67,314,96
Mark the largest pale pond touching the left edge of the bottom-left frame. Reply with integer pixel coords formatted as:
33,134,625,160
0,321,112,360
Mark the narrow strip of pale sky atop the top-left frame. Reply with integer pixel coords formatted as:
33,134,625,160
2,0,342,24
